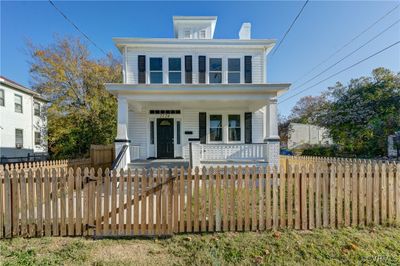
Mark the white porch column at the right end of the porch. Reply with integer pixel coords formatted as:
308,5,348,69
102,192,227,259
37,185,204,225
264,97,280,166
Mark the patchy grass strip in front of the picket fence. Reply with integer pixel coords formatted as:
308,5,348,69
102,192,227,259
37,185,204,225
0,228,400,265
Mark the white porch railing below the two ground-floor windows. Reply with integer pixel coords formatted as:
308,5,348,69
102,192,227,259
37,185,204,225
199,143,268,161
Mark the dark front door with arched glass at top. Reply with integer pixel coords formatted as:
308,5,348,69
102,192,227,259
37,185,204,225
157,118,174,158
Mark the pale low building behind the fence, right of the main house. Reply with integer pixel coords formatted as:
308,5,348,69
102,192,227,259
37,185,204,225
288,123,333,149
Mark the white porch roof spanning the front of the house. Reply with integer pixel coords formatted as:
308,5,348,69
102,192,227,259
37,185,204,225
105,83,290,101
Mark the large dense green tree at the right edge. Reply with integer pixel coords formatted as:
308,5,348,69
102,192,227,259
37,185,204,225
317,68,400,157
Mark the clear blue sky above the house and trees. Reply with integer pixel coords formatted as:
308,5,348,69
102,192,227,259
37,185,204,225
0,0,400,116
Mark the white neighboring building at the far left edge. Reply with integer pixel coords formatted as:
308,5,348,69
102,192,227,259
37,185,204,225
0,76,47,163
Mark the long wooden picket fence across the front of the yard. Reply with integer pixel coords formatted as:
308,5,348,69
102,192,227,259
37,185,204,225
0,163,400,238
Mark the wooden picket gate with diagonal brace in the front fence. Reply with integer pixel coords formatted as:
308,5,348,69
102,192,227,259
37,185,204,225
90,169,175,237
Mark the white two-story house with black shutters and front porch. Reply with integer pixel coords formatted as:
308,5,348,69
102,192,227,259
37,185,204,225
106,16,290,168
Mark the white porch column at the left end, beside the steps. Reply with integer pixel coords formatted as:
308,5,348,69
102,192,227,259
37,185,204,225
114,96,131,169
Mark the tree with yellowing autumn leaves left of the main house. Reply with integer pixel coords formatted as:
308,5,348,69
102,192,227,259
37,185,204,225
29,38,122,158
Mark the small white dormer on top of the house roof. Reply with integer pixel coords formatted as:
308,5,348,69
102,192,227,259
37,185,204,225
173,16,217,39
